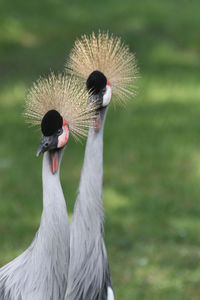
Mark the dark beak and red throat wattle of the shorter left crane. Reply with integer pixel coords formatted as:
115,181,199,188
36,136,59,174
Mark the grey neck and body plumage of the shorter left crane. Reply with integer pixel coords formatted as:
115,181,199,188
0,150,69,300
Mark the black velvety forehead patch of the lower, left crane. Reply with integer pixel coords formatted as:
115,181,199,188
41,109,63,136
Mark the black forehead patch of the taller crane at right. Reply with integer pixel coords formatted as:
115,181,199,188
86,71,107,94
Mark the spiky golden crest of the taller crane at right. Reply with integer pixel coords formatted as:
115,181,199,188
66,32,138,102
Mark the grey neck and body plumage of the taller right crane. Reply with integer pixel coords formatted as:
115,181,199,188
65,108,112,300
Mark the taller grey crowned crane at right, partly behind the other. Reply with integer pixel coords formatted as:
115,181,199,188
65,32,137,300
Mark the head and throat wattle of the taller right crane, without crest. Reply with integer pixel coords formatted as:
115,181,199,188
86,70,112,131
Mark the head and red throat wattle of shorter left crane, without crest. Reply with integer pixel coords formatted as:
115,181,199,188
37,109,69,174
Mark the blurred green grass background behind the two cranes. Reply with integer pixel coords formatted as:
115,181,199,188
0,0,200,300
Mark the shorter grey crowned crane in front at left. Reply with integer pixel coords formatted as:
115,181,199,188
0,74,95,300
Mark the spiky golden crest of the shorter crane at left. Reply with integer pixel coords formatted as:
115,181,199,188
24,73,96,139
